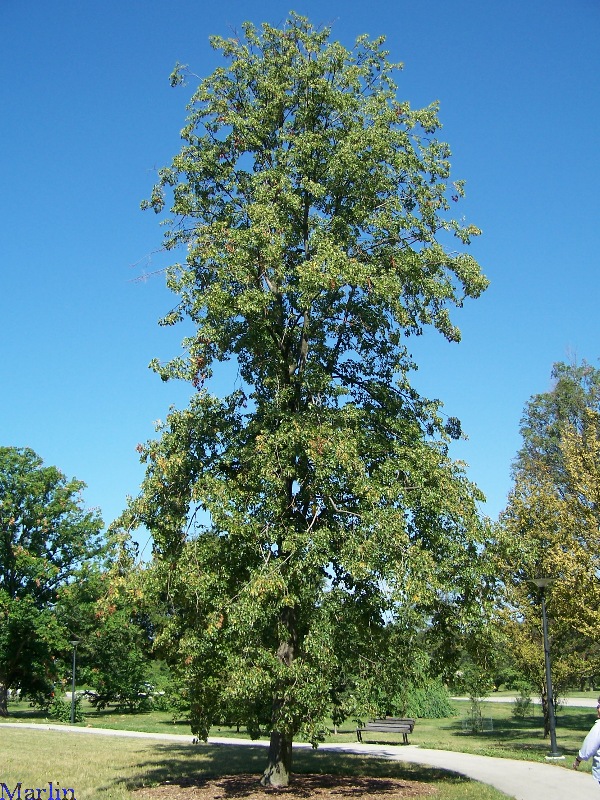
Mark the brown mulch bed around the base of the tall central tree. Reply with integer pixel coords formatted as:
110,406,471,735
132,774,436,800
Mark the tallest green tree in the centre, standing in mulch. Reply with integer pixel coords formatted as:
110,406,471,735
126,15,487,785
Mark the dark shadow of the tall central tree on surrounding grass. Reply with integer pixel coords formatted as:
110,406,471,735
101,744,478,797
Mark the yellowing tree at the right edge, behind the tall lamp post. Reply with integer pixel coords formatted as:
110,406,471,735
494,363,600,732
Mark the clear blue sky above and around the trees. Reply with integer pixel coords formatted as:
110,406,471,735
0,0,600,552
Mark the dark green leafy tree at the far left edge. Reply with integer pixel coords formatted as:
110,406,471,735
0,447,103,716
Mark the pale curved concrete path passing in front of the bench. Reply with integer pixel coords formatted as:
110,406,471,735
0,722,600,800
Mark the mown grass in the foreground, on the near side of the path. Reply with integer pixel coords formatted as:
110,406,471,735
0,727,505,800
